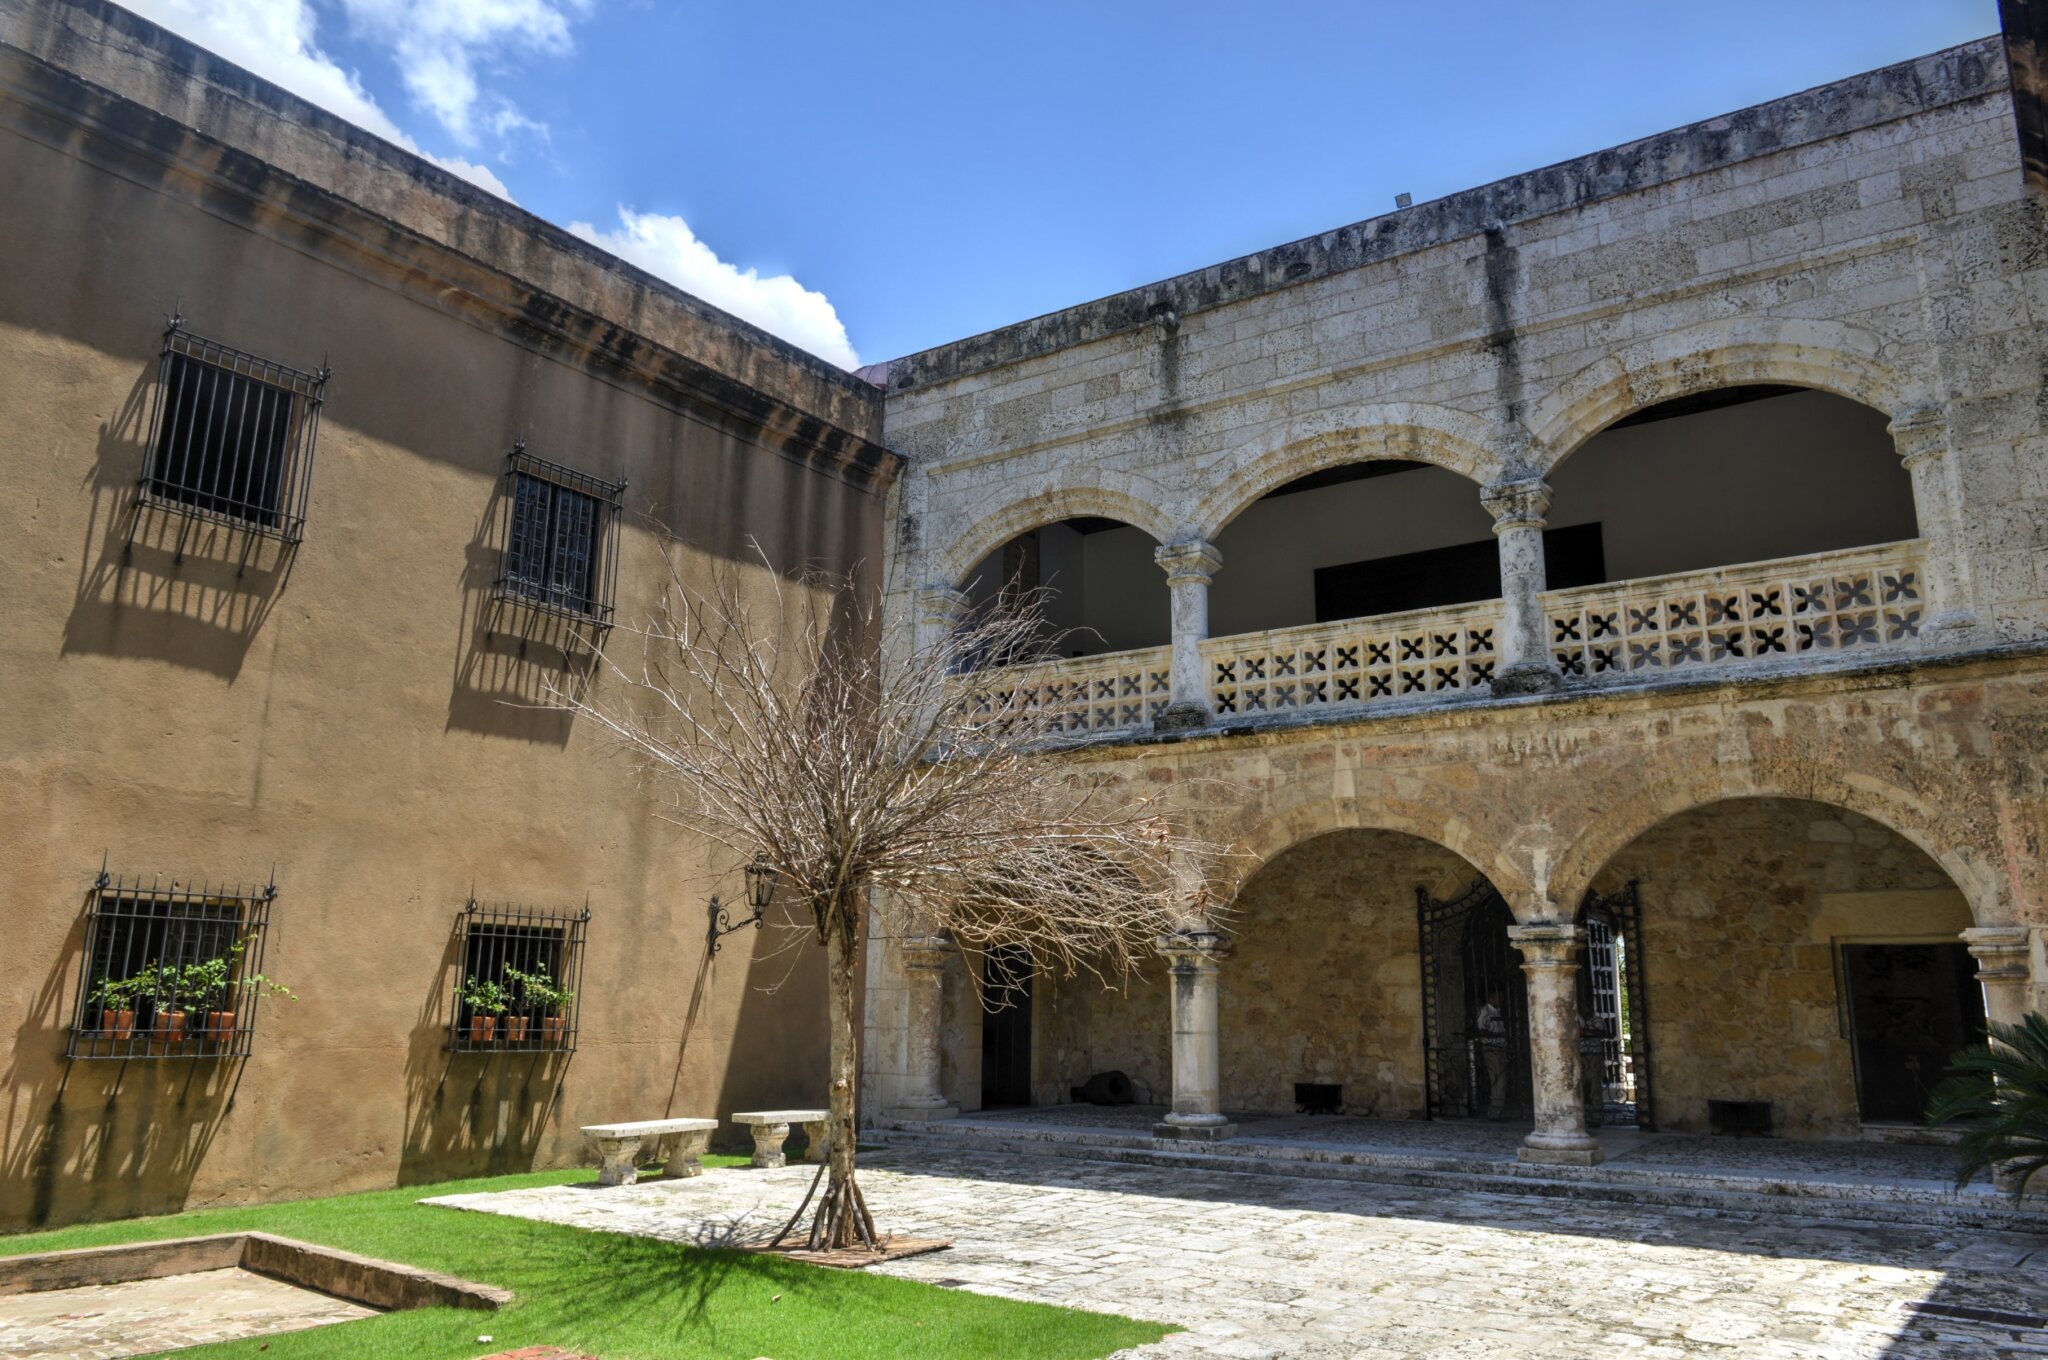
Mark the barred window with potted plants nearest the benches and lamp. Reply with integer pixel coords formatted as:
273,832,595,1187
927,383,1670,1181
449,899,590,1053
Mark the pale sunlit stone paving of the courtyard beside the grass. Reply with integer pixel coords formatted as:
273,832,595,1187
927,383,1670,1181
430,1149,2048,1360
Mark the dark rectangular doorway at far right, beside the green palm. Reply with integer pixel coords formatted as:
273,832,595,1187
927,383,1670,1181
1841,944,1985,1124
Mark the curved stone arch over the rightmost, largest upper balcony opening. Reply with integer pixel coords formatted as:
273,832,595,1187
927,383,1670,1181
1528,317,1927,473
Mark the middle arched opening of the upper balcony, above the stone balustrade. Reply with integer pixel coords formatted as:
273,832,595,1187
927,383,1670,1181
1208,459,1501,637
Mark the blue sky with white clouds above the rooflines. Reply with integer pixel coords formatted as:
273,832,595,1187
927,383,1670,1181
131,0,1997,365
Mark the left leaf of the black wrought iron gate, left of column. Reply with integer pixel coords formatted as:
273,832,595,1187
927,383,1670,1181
1415,879,1532,1120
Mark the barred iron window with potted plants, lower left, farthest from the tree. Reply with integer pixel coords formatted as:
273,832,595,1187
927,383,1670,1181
63,868,276,1059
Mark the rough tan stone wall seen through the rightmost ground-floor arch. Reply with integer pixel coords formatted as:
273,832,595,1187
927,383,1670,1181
1602,799,1970,1137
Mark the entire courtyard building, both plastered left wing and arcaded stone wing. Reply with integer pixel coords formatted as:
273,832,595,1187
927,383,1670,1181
0,0,2048,1229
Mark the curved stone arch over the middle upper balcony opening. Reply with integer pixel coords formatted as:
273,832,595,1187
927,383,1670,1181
1188,401,1511,539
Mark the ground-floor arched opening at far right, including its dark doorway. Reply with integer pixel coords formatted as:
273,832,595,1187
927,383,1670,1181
1593,799,1985,1139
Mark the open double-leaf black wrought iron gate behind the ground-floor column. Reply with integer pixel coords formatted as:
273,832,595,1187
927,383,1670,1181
1415,879,1651,1129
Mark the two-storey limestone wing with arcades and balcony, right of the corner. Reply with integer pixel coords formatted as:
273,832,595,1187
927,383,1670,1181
866,21,2048,1163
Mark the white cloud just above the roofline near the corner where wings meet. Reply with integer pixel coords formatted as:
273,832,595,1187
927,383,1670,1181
569,207,860,369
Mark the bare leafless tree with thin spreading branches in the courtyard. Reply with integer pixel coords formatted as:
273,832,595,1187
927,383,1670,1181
557,549,1221,1249
